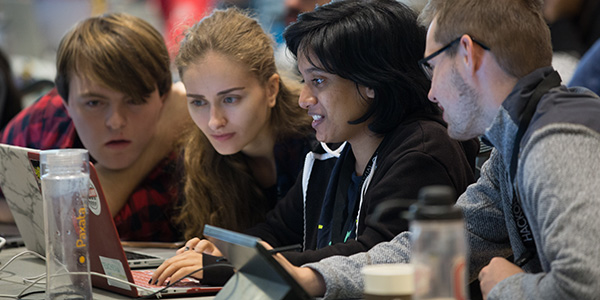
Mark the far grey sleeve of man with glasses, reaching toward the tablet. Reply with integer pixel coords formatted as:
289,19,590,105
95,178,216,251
304,150,511,299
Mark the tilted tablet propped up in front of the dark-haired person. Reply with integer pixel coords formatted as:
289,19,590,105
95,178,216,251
203,225,311,300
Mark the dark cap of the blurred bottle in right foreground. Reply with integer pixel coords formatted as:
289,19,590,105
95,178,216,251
409,185,463,220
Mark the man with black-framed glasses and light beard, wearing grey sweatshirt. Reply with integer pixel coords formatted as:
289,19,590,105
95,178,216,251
278,0,600,299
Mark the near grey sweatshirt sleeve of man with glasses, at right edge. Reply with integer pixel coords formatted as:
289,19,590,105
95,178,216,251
488,124,600,300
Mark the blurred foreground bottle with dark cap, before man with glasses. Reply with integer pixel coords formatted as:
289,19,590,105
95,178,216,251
410,186,468,300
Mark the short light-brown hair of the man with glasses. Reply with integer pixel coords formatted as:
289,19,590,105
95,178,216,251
419,0,552,78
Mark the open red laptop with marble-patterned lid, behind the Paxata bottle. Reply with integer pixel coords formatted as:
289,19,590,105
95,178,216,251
0,144,221,297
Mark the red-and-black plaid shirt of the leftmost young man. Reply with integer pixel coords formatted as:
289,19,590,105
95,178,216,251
0,89,183,242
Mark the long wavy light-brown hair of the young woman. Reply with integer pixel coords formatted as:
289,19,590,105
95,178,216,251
175,8,310,238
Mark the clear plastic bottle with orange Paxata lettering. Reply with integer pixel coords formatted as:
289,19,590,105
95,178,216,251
40,149,92,299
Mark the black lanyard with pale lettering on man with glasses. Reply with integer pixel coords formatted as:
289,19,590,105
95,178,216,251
510,71,561,267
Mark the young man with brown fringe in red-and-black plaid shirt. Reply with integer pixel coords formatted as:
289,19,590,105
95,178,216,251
1,13,190,241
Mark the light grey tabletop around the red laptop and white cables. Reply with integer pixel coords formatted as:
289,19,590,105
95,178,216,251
0,247,214,300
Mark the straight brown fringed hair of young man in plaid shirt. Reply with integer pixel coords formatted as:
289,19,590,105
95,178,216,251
55,13,172,102
